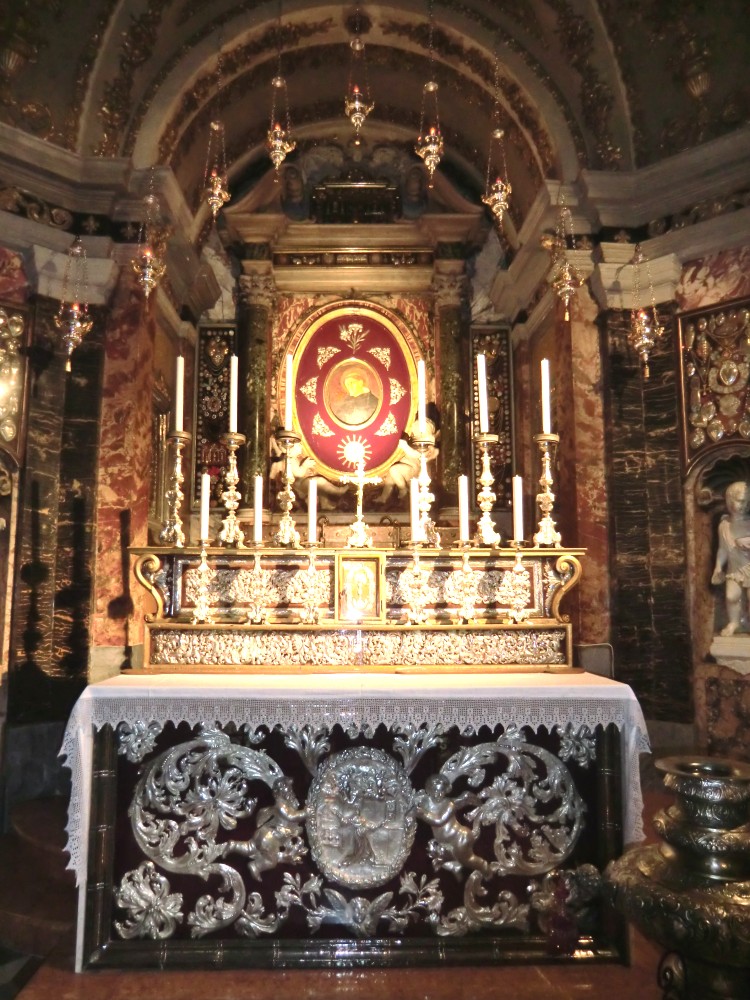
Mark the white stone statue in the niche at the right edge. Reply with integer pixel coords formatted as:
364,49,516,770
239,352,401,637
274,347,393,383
711,480,750,635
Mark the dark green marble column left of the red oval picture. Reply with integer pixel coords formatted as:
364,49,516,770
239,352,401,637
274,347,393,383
237,270,276,506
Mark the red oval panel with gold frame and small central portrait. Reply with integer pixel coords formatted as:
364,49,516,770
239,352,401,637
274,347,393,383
278,302,421,481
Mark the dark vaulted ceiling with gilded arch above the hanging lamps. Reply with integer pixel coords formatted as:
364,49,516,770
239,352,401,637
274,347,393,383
0,0,750,230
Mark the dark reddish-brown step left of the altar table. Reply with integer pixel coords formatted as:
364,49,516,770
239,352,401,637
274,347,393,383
0,798,76,960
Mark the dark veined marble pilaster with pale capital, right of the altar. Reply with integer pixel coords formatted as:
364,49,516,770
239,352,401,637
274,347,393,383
591,244,693,723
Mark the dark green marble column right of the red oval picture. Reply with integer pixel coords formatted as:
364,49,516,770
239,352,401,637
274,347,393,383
433,260,469,507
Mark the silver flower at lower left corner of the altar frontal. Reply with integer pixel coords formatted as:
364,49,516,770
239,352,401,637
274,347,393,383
115,861,183,940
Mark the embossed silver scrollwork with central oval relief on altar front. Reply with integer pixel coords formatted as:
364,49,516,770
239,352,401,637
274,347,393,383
114,723,596,940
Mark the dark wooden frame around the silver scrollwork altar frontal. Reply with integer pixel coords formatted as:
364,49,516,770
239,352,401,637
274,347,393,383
82,723,629,970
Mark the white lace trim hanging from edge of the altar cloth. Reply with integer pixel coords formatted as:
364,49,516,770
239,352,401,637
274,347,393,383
60,681,650,886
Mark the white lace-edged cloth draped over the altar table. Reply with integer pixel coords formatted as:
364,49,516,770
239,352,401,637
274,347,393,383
60,672,650,889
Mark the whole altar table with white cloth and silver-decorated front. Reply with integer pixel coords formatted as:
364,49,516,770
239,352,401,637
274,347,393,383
61,671,649,971
